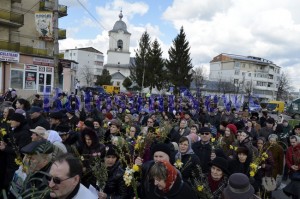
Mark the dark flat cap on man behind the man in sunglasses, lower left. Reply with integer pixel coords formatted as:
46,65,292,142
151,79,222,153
21,140,53,154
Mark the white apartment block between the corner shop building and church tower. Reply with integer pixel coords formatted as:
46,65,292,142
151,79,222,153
64,47,104,86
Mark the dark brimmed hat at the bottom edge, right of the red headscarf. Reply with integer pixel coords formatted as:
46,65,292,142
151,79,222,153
223,173,254,199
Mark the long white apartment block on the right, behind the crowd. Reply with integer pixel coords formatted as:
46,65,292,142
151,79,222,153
209,53,280,101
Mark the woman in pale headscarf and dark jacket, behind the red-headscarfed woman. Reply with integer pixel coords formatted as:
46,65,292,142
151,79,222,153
175,136,200,182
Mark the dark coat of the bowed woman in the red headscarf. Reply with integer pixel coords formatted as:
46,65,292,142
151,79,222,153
145,172,197,199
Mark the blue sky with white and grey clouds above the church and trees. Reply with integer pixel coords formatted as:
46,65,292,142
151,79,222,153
59,0,300,91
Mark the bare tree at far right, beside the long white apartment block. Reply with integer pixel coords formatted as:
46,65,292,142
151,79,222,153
276,72,292,101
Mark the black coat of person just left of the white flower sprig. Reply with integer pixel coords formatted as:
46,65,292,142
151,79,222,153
103,161,128,199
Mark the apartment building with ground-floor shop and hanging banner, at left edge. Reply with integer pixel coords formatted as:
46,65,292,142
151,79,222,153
0,0,67,97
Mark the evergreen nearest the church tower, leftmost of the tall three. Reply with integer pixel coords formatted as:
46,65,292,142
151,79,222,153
130,31,150,88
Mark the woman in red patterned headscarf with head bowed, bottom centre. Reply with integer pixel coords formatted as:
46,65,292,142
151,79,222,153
145,161,197,199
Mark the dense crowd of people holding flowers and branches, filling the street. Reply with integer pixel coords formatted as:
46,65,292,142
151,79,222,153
0,90,300,199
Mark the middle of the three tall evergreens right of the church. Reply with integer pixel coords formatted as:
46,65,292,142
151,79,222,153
147,39,166,92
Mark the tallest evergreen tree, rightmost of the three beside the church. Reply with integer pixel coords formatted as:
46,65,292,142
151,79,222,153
166,27,193,93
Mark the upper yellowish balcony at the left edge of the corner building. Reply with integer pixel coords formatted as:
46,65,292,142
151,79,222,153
0,9,24,28
